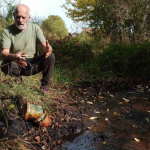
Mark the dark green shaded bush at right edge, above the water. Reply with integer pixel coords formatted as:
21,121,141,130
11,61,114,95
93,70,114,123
100,42,150,77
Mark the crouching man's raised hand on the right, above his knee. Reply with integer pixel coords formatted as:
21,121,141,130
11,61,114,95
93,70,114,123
40,40,52,58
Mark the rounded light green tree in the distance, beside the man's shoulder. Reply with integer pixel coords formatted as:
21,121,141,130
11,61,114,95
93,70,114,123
41,15,68,39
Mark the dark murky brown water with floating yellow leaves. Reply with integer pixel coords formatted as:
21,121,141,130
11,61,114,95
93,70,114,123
55,86,150,150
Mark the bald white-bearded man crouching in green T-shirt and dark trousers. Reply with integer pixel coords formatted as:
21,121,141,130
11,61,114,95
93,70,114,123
1,4,55,91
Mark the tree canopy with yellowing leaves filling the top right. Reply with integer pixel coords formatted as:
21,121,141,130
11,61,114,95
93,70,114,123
63,0,150,44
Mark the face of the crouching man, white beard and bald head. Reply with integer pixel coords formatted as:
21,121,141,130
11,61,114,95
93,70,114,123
14,8,30,31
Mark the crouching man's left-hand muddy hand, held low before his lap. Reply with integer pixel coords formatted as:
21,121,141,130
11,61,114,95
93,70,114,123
15,52,27,67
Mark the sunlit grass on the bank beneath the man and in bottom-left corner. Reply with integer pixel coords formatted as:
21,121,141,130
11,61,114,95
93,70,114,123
0,63,84,150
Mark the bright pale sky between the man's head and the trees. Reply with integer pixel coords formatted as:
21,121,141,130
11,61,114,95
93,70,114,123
20,0,82,33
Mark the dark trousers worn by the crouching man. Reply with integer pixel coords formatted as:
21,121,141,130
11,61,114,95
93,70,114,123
1,53,55,86
